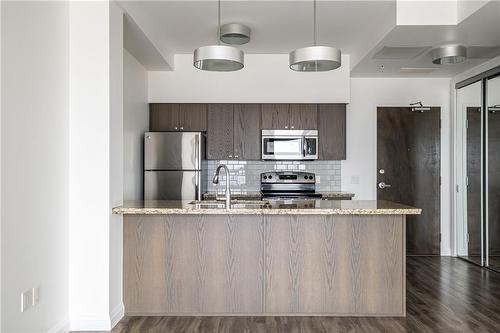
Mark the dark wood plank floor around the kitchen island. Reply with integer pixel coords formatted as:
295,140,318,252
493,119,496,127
85,257,500,333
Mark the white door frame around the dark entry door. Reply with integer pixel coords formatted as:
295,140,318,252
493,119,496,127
373,105,444,256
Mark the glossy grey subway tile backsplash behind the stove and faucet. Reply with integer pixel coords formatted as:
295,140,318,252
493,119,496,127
204,160,341,193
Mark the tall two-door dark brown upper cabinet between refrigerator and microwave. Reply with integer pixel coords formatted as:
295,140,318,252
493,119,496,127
207,104,261,160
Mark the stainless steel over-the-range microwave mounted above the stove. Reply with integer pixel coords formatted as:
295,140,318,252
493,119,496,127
262,130,318,161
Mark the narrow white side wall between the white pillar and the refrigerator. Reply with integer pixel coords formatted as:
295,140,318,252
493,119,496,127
123,51,149,200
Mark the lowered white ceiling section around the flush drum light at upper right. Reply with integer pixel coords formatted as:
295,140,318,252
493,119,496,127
351,1,500,77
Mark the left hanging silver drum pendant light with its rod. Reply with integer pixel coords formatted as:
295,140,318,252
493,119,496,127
193,0,244,72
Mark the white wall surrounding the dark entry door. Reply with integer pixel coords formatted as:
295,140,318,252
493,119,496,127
342,78,451,255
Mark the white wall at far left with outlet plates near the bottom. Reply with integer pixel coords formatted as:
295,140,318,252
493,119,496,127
1,2,69,332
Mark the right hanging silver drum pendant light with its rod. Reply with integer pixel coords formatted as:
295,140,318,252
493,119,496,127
290,0,342,72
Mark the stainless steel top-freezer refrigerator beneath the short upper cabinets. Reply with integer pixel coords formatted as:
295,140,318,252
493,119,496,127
144,132,206,200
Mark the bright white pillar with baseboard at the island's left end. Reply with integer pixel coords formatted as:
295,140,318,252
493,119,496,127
69,1,123,330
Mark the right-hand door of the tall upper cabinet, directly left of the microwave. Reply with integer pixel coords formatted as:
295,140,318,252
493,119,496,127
233,104,262,160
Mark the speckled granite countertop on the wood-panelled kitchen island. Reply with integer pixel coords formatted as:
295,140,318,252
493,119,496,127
113,200,422,215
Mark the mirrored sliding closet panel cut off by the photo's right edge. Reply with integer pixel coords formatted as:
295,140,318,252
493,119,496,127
486,76,500,270
